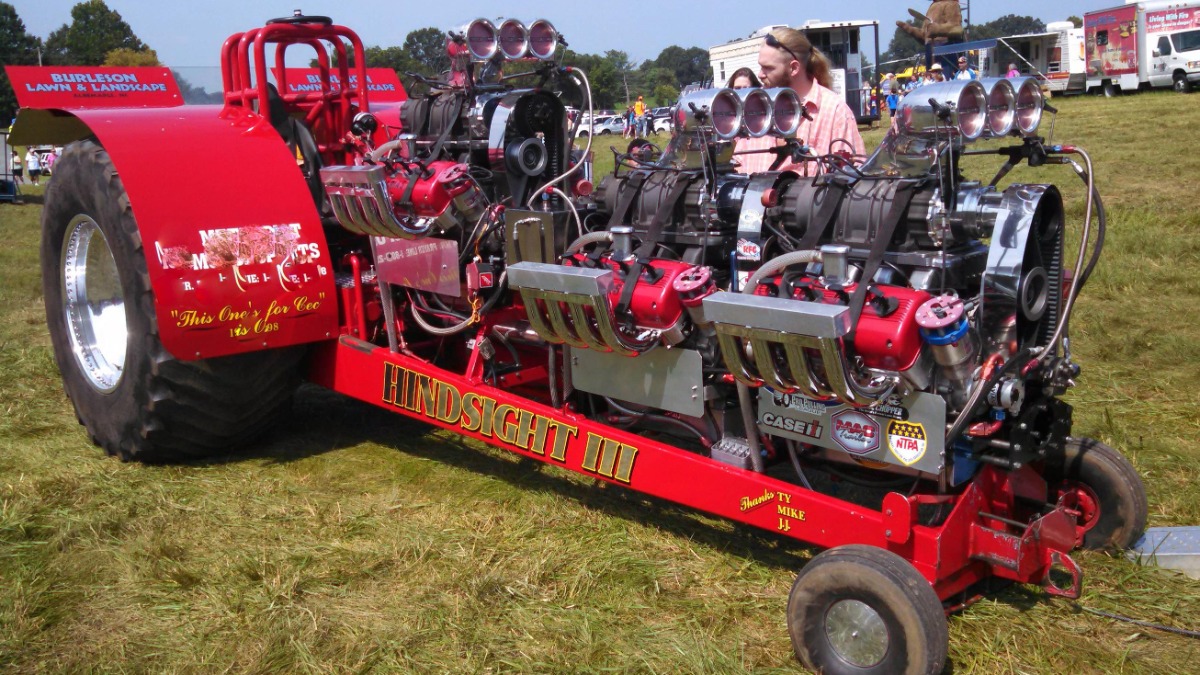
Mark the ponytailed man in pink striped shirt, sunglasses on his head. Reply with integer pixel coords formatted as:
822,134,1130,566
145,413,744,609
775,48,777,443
737,28,866,175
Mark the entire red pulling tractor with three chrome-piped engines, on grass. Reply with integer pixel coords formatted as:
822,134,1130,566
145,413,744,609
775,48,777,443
13,16,1147,673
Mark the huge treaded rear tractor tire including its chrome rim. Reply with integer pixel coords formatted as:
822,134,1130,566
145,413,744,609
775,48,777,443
41,141,304,462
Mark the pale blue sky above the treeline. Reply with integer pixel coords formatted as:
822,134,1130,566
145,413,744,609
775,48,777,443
16,0,1104,66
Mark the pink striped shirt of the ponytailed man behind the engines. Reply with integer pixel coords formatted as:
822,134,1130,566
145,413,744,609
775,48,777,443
734,82,866,175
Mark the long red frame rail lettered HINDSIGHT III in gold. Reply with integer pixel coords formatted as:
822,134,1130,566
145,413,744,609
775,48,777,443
308,276,1082,605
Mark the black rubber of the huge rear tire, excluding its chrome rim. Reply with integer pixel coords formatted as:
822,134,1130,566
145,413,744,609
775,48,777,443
42,141,304,462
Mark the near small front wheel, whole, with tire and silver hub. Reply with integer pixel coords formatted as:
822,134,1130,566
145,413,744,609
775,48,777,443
787,545,949,675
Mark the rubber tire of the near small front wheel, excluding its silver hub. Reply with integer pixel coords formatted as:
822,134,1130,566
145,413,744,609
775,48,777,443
787,544,949,675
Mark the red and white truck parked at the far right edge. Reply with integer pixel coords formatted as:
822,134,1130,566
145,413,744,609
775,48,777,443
1084,0,1200,96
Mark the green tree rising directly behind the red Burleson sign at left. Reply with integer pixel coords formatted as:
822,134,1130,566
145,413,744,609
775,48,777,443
46,0,146,66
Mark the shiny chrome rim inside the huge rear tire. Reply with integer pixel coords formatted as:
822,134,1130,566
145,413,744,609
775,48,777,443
61,215,130,394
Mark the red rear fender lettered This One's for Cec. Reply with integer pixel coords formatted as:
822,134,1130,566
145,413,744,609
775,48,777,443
11,106,337,360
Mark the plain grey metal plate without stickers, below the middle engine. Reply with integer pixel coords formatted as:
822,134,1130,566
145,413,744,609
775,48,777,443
568,348,704,417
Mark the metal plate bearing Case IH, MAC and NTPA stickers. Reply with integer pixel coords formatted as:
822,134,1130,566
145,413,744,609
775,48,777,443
758,387,946,473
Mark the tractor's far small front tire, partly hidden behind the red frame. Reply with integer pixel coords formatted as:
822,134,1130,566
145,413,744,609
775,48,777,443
1051,438,1150,550
